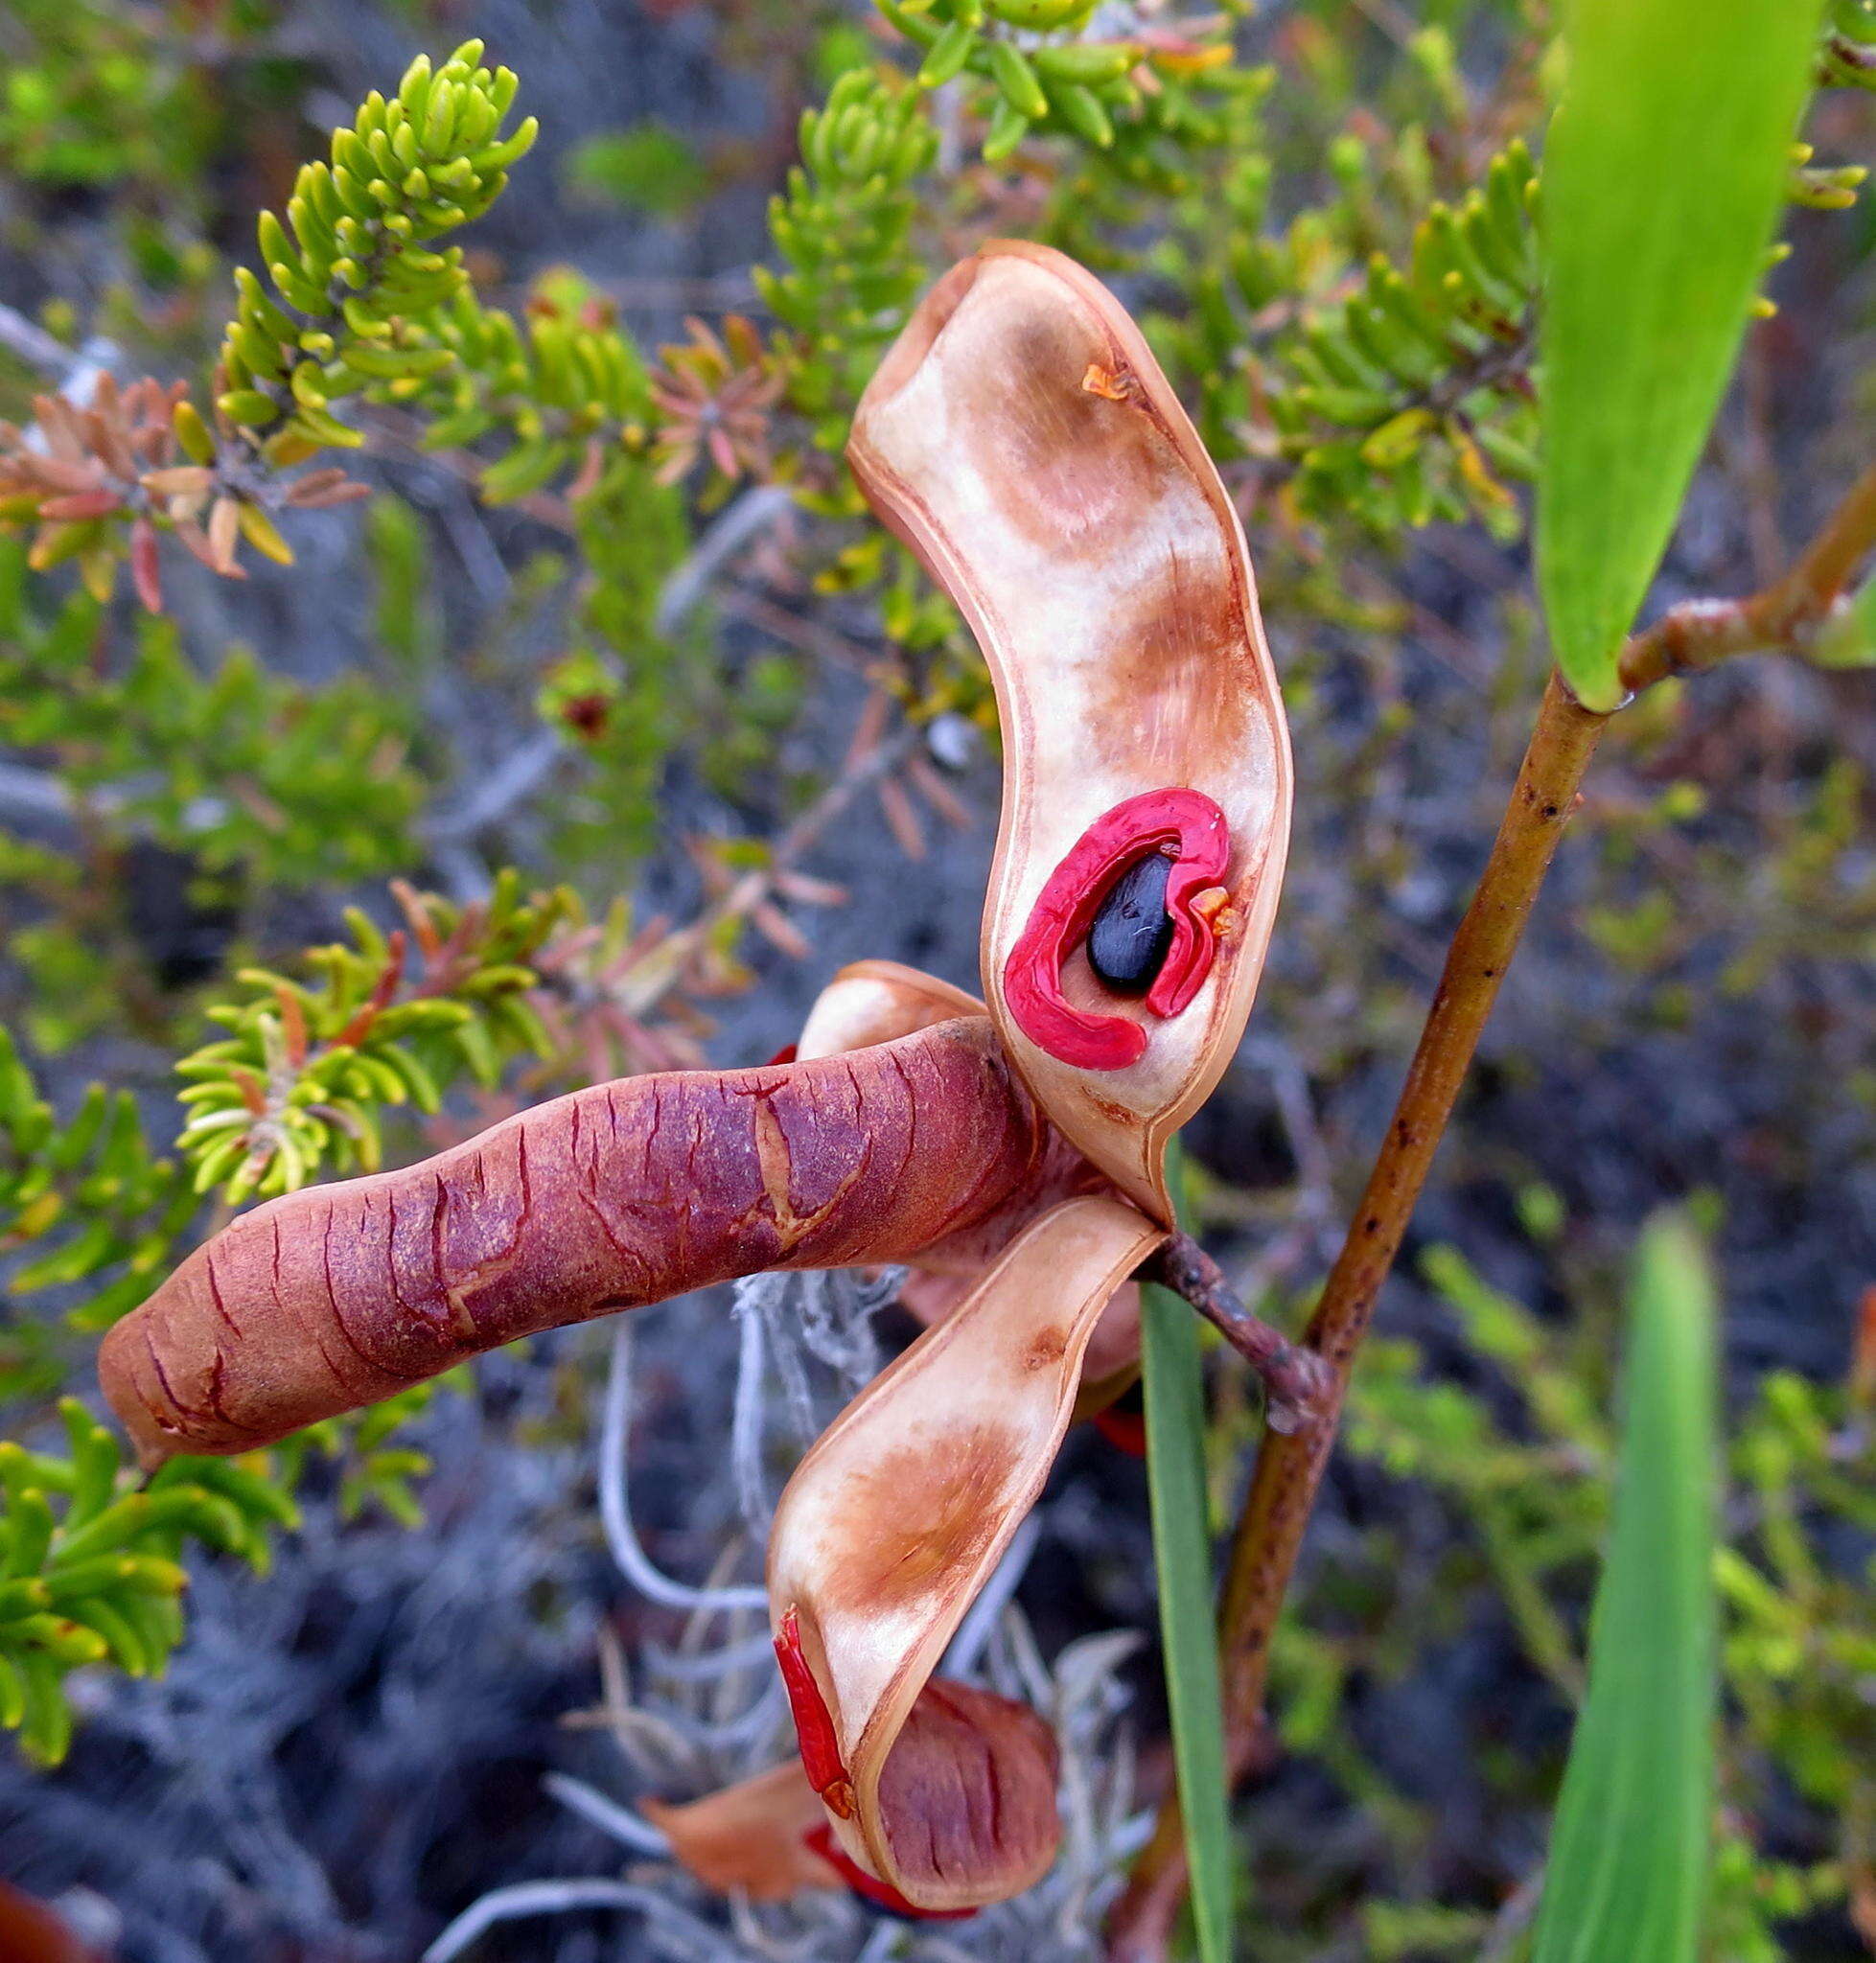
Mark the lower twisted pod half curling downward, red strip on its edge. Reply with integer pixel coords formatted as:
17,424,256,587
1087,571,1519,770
769,1195,1164,1912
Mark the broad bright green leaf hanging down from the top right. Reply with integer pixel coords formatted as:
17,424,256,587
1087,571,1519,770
1537,0,1819,708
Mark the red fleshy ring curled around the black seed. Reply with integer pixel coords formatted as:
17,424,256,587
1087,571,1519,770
1003,787,1231,1070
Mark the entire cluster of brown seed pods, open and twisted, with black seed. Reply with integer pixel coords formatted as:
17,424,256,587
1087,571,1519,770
100,245,1289,1914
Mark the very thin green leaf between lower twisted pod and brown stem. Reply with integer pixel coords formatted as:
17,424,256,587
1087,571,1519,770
1140,1144,1233,1963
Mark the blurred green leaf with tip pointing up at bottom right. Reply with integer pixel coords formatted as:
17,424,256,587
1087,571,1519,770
1531,1215,1719,1963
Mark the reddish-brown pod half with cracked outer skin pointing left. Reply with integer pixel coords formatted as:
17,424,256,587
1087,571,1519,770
98,1017,1048,1463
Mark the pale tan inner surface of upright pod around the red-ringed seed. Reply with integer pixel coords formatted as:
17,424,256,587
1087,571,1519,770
847,242,1291,1219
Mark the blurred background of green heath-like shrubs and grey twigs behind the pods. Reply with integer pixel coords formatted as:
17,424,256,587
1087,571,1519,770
0,0,1876,1963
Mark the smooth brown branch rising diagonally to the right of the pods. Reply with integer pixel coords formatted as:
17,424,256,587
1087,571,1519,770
1109,465,1876,1963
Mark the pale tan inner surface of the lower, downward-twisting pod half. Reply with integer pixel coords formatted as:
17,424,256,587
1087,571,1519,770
769,1197,1162,1908
